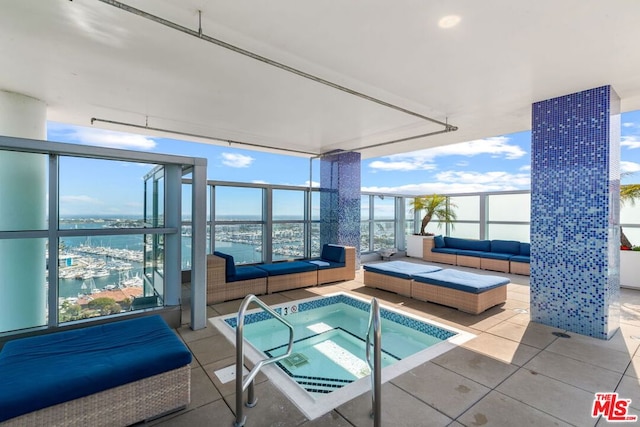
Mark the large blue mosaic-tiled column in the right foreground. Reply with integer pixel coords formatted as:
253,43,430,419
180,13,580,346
531,86,620,339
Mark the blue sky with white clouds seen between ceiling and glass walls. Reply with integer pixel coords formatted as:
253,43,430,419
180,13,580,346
47,111,640,215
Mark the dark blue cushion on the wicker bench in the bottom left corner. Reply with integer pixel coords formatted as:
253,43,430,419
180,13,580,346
0,316,191,421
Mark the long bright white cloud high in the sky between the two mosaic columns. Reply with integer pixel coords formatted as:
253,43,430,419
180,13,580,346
369,136,527,171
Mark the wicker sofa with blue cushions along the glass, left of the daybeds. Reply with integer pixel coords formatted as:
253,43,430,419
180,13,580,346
207,244,356,304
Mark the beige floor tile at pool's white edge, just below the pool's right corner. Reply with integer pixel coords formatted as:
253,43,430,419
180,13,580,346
431,347,518,388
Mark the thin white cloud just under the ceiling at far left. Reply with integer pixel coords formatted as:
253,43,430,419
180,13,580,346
48,123,157,151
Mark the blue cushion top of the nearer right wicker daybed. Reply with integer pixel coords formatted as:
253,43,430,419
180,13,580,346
412,269,509,294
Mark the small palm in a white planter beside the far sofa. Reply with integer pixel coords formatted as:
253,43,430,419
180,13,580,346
406,194,457,258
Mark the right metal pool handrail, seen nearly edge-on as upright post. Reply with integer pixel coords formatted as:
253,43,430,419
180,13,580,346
366,298,382,427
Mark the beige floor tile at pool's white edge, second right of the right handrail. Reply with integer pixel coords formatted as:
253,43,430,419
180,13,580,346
392,362,491,419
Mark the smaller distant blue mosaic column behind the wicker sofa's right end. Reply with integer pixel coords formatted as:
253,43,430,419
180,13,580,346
320,151,360,259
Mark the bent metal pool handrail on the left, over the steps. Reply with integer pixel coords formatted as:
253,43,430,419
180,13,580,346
233,294,293,427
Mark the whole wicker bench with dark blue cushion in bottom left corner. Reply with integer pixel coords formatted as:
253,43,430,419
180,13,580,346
0,316,191,427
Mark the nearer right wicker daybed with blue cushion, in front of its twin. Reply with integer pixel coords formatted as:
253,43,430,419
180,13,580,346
411,269,509,314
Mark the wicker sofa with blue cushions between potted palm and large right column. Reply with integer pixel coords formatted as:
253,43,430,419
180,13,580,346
422,236,531,276
